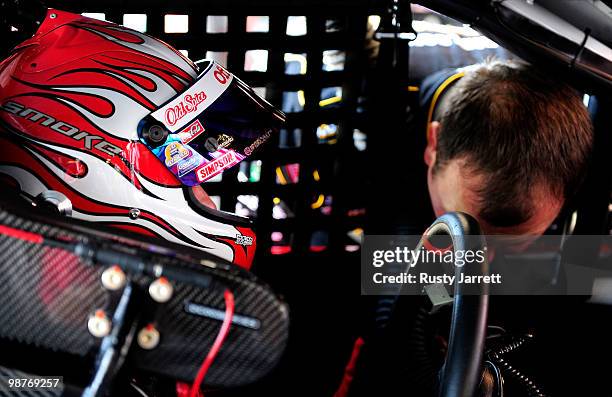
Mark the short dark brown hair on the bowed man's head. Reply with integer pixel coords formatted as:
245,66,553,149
434,61,593,227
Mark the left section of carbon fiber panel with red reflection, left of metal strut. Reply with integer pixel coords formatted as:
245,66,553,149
0,213,111,356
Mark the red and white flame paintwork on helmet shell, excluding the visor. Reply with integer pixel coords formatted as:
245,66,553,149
0,12,253,263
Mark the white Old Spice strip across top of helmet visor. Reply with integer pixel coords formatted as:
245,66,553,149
151,62,234,132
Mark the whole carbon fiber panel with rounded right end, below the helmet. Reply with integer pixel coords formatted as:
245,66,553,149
0,203,289,386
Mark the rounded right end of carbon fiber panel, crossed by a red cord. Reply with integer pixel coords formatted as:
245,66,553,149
134,266,288,385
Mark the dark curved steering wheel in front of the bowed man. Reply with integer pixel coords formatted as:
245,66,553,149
416,212,489,397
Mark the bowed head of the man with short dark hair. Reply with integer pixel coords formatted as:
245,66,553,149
425,61,592,234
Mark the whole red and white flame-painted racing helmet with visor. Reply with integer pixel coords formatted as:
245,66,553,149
0,9,285,268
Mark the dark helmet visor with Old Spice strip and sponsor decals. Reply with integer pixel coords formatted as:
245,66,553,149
138,61,285,186
